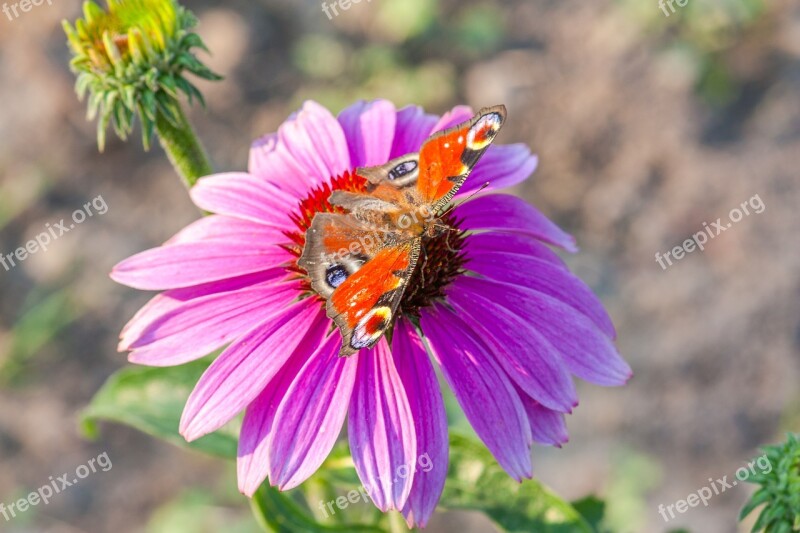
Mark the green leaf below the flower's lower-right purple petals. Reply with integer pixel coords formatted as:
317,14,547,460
440,435,594,533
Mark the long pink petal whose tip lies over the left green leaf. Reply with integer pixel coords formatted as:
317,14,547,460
180,298,330,441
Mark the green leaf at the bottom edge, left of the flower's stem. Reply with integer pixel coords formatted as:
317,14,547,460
251,483,385,533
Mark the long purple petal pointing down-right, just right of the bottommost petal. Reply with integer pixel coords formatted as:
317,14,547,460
421,305,532,481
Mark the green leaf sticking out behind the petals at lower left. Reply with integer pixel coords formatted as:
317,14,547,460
81,358,237,458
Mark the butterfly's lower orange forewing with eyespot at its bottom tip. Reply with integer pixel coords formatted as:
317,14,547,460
328,239,420,356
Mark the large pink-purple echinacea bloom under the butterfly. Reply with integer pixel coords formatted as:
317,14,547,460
112,100,631,526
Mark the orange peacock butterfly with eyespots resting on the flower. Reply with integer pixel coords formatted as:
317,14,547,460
297,105,506,356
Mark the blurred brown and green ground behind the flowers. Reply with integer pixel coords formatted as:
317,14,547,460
0,0,800,533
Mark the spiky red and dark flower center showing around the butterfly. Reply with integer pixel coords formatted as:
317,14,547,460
284,172,466,317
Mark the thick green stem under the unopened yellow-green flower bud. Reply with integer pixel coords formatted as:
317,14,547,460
156,105,214,189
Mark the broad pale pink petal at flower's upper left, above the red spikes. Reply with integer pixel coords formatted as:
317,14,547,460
276,100,352,184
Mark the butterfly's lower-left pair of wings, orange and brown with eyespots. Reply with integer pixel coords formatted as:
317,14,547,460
298,213,420,356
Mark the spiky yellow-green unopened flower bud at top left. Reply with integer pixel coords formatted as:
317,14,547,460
63,0,220,150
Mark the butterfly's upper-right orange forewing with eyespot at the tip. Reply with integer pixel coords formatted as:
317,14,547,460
417,105,506,212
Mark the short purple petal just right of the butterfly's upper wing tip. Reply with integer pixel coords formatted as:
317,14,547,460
457,144,539,197
